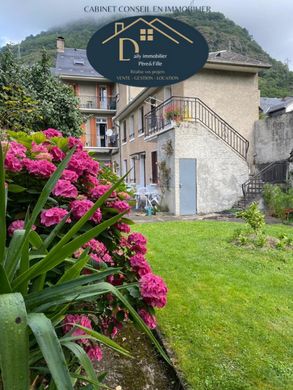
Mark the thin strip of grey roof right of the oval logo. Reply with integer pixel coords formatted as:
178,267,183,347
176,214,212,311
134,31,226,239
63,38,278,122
208,50,271,68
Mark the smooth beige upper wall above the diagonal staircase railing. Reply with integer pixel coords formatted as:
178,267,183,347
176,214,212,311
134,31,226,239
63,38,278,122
183,69,259,163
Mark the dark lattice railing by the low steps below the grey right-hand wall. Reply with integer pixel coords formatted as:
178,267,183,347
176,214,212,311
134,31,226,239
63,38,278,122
242,160,289,197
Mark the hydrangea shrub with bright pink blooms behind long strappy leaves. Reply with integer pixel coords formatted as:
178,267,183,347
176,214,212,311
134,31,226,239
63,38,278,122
2,129,167,361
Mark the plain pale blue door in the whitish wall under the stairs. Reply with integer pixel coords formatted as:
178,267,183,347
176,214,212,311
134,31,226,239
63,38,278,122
179,158,196,215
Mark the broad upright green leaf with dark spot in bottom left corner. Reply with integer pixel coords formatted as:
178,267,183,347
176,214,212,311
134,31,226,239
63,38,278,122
0,293,29,390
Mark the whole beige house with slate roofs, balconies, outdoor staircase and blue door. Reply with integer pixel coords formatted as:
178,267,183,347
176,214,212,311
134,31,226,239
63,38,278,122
56,38,270,215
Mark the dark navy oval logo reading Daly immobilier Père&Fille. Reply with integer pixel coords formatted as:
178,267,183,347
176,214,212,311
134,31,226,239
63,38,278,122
87,15,209,87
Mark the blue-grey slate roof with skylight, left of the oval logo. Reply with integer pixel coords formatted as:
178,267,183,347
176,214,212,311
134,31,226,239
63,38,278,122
53,48,103,78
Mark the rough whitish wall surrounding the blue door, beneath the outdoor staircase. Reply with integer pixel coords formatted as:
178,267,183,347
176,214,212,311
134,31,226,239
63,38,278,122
158,123,249,215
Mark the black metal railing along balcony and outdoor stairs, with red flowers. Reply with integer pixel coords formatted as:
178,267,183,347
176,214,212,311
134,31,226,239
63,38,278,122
145,96,249,159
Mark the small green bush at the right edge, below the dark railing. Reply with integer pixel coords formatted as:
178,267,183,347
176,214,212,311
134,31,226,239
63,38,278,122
263,184,293,220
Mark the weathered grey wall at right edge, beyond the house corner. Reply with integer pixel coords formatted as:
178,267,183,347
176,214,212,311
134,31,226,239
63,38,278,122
254,112,293,164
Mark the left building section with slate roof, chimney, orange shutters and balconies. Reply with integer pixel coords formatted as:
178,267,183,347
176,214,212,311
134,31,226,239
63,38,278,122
54,37,118,162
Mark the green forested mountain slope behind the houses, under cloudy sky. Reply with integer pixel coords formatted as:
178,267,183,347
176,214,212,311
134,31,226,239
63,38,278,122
4,12,293,97
